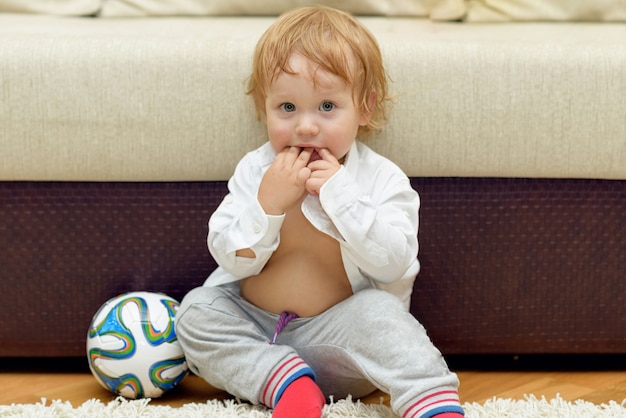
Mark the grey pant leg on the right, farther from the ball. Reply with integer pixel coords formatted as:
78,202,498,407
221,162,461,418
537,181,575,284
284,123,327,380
279,289,460,416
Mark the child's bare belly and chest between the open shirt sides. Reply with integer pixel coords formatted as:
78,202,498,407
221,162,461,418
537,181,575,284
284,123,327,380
241,202,352,317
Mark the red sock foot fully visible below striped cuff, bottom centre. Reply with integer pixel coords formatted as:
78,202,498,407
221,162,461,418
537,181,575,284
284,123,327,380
272,376,326,418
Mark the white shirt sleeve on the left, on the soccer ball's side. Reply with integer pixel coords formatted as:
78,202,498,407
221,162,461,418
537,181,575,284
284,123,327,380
207,154,284,281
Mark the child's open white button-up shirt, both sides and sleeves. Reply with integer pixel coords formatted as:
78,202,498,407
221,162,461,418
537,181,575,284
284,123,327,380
205,141,420,310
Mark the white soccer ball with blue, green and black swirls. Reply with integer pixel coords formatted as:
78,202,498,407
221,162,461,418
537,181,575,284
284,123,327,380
87,292,188,399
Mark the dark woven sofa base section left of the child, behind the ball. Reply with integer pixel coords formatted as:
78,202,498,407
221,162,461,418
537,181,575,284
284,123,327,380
0,183,221,356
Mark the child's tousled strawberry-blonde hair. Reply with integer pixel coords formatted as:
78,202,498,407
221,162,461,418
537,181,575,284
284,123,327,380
247,6,390,133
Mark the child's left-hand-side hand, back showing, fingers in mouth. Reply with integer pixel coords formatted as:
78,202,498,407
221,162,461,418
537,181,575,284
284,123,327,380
258,147,313,215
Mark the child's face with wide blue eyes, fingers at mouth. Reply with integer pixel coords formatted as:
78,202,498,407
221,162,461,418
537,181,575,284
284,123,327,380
265,54,368,160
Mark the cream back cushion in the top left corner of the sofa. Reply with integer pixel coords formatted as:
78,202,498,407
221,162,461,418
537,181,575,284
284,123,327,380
0,0,102,16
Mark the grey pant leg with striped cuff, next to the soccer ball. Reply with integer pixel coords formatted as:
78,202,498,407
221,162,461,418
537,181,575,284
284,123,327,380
175,287,314,408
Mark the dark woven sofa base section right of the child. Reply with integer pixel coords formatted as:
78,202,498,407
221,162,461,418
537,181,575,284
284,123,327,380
412,179,626,354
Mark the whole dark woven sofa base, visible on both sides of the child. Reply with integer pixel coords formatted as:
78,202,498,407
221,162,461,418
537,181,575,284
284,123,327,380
0,178,626,357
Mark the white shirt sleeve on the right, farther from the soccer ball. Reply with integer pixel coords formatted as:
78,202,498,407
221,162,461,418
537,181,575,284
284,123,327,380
304,166,419,284
